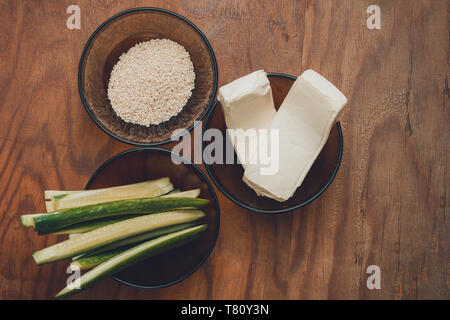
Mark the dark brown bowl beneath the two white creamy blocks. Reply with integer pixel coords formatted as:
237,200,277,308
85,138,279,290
203,74,343,213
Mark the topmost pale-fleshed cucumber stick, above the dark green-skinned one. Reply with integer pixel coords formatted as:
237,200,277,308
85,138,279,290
51,177,173,211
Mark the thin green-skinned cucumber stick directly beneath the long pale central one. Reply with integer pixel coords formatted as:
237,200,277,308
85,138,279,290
72,222,198,260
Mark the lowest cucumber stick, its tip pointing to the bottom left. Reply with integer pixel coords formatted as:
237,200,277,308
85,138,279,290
56,225,206,298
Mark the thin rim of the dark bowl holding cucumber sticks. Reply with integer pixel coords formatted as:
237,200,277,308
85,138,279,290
84,147,220,289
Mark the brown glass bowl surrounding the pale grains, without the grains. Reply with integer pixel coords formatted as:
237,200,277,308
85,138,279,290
78,8,218,146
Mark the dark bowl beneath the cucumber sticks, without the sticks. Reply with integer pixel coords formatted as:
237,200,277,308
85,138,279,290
86,148,220,289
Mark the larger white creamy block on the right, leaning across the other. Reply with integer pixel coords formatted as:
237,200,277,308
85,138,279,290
243,70,347,201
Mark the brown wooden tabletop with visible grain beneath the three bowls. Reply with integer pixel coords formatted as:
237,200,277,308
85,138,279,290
0,0,450,299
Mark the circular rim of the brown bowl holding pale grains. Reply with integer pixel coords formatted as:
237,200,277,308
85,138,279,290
78,7,219,147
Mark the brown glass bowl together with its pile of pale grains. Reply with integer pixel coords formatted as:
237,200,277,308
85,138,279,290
78,8,217,146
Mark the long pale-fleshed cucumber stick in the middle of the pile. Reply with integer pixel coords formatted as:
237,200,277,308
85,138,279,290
33,210,205,264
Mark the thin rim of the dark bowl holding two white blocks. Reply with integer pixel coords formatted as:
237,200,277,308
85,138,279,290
202,73,344,214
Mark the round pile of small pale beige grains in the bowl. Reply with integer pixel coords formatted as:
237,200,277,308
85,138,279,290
108,39,195,126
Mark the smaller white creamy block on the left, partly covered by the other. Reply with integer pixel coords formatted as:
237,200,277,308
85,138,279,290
217,70,276,169
